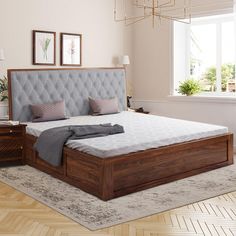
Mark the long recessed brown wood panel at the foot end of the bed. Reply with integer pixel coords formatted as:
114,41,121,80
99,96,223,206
113,137,228,191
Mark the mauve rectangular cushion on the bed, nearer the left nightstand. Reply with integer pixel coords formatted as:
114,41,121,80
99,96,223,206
31,101,66,122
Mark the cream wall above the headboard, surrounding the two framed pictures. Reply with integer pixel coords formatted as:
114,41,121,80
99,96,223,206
0,0,130,74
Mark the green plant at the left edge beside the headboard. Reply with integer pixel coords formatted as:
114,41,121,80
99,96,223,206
0,76,8,118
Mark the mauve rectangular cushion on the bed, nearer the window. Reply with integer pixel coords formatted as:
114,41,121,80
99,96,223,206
89,98,119,115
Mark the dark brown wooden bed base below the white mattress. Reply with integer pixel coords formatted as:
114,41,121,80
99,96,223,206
25,134,233,200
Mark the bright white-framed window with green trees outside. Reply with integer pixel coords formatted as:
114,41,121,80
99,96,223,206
173,15,236,96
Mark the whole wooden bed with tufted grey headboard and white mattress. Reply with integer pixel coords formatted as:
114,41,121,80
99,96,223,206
8,68,233,200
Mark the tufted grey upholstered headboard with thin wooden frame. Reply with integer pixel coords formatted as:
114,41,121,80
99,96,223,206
8,68,126,121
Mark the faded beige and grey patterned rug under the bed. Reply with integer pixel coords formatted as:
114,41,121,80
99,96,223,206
0,160,236,230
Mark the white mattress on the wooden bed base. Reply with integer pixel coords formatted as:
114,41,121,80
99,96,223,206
26,111,228,158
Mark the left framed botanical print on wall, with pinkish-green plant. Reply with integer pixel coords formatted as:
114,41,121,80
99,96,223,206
33,30,56,65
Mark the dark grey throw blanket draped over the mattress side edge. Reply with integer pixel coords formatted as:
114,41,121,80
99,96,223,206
34,124,124,166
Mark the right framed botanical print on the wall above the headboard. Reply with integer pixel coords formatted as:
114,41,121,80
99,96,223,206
61,33,82,66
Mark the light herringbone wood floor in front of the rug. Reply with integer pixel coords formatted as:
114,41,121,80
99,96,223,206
0,182,236,236
